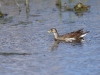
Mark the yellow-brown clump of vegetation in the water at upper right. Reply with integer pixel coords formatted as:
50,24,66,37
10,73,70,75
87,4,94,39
56,0,90,13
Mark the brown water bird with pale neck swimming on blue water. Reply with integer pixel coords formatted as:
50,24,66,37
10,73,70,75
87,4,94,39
48,28,89,42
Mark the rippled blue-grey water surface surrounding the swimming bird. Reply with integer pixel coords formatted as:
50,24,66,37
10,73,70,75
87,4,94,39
0,0,100,75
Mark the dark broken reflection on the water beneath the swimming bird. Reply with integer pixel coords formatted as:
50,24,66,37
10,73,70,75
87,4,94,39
50,38,85,51
